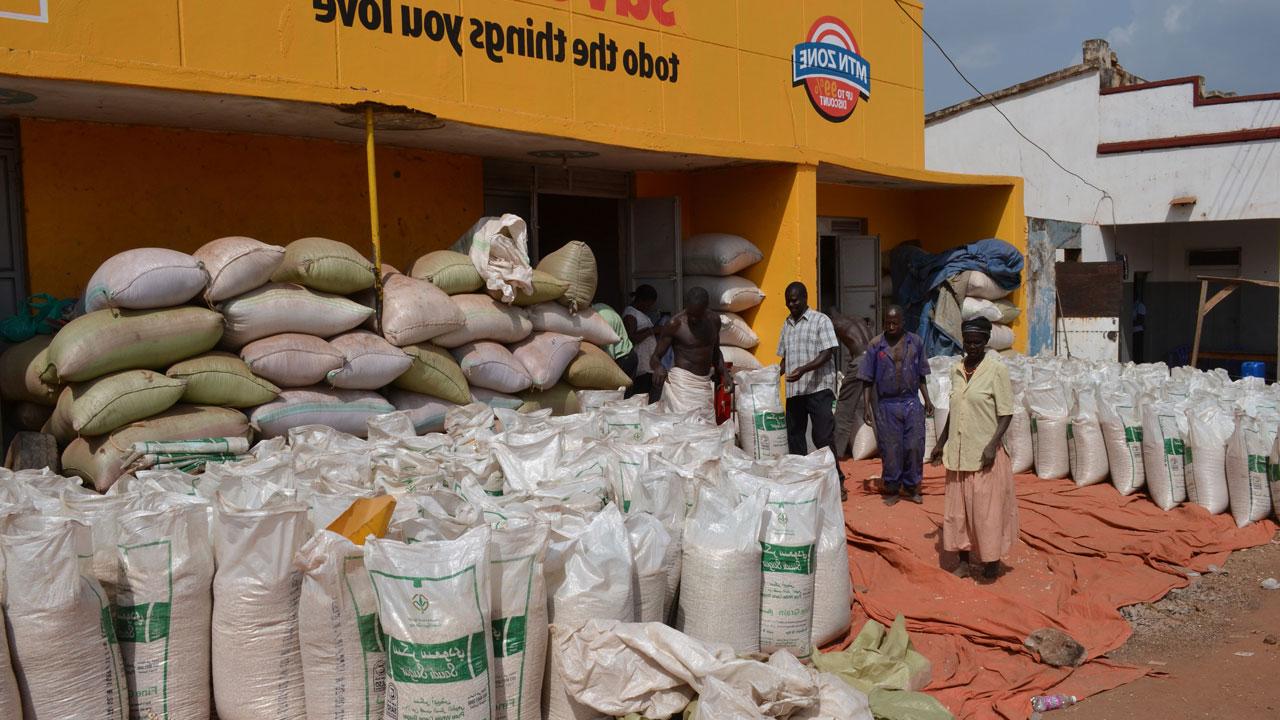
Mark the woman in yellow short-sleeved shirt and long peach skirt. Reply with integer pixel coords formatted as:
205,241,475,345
929,318,1018,580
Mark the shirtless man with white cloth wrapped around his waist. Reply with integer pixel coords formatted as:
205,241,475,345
650,287,727,424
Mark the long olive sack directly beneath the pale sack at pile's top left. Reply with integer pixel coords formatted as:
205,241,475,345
40,307,223,383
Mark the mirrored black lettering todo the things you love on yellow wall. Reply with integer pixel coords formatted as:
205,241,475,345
311,0,680,83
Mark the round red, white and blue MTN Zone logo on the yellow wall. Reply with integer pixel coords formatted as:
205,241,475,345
791,15,872,123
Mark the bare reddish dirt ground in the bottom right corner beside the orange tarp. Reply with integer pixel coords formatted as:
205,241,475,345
1044,534,1280,720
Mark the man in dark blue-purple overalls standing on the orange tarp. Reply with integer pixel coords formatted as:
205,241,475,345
858,305,933,505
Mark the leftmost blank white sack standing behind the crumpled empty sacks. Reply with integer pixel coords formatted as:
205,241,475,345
543,505,635,720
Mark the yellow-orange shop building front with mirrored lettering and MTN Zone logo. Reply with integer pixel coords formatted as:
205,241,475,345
0,0,1027,353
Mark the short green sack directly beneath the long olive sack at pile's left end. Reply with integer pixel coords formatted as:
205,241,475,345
70,370,187,436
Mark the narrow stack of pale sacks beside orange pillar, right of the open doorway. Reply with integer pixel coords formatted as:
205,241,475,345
681,233,764,370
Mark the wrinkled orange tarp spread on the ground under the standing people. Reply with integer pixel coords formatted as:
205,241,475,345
837,461,1276,720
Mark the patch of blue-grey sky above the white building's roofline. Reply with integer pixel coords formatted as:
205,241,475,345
921,0,1280,111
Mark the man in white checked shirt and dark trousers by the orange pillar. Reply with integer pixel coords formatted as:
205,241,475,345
778,282,845,489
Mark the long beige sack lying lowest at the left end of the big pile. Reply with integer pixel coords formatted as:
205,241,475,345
63,405,250,492
